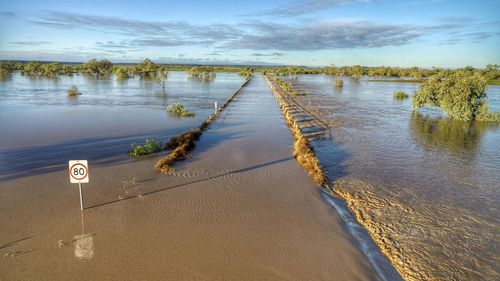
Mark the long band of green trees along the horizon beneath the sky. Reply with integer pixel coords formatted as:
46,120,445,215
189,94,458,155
0,58,500,83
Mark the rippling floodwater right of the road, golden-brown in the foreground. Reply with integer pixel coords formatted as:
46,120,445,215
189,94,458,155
290,75,500,280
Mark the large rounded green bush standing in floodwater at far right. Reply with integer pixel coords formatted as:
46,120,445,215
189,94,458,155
413,70,500,122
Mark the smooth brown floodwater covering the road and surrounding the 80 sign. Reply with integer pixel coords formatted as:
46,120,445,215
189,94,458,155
0,76,379,280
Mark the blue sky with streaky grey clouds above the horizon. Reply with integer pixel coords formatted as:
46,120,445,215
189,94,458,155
0,0,500,68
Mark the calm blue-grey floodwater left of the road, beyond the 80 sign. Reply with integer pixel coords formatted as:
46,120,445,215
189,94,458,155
0,71,244,179
